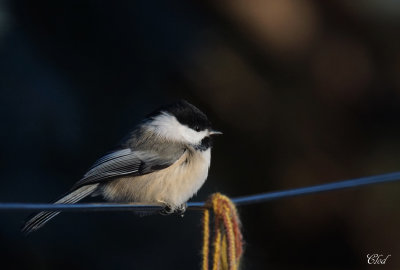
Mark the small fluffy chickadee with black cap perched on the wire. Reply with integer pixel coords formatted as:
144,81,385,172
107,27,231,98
22,100,222,233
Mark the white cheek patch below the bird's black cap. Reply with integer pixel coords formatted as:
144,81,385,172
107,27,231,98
149,112,208,144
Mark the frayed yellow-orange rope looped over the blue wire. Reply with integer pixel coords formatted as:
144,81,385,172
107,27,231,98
202,193,243,270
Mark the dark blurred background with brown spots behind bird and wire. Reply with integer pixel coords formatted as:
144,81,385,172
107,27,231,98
0,0,400,269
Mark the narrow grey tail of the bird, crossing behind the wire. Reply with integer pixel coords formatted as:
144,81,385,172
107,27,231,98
22,184,98,234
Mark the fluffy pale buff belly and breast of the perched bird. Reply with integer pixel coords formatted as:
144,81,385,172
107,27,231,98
103,149,211,208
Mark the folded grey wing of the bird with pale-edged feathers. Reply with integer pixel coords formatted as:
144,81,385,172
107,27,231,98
72,148,185,190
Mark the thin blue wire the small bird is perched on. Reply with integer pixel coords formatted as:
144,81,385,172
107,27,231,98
0,172,400,212
